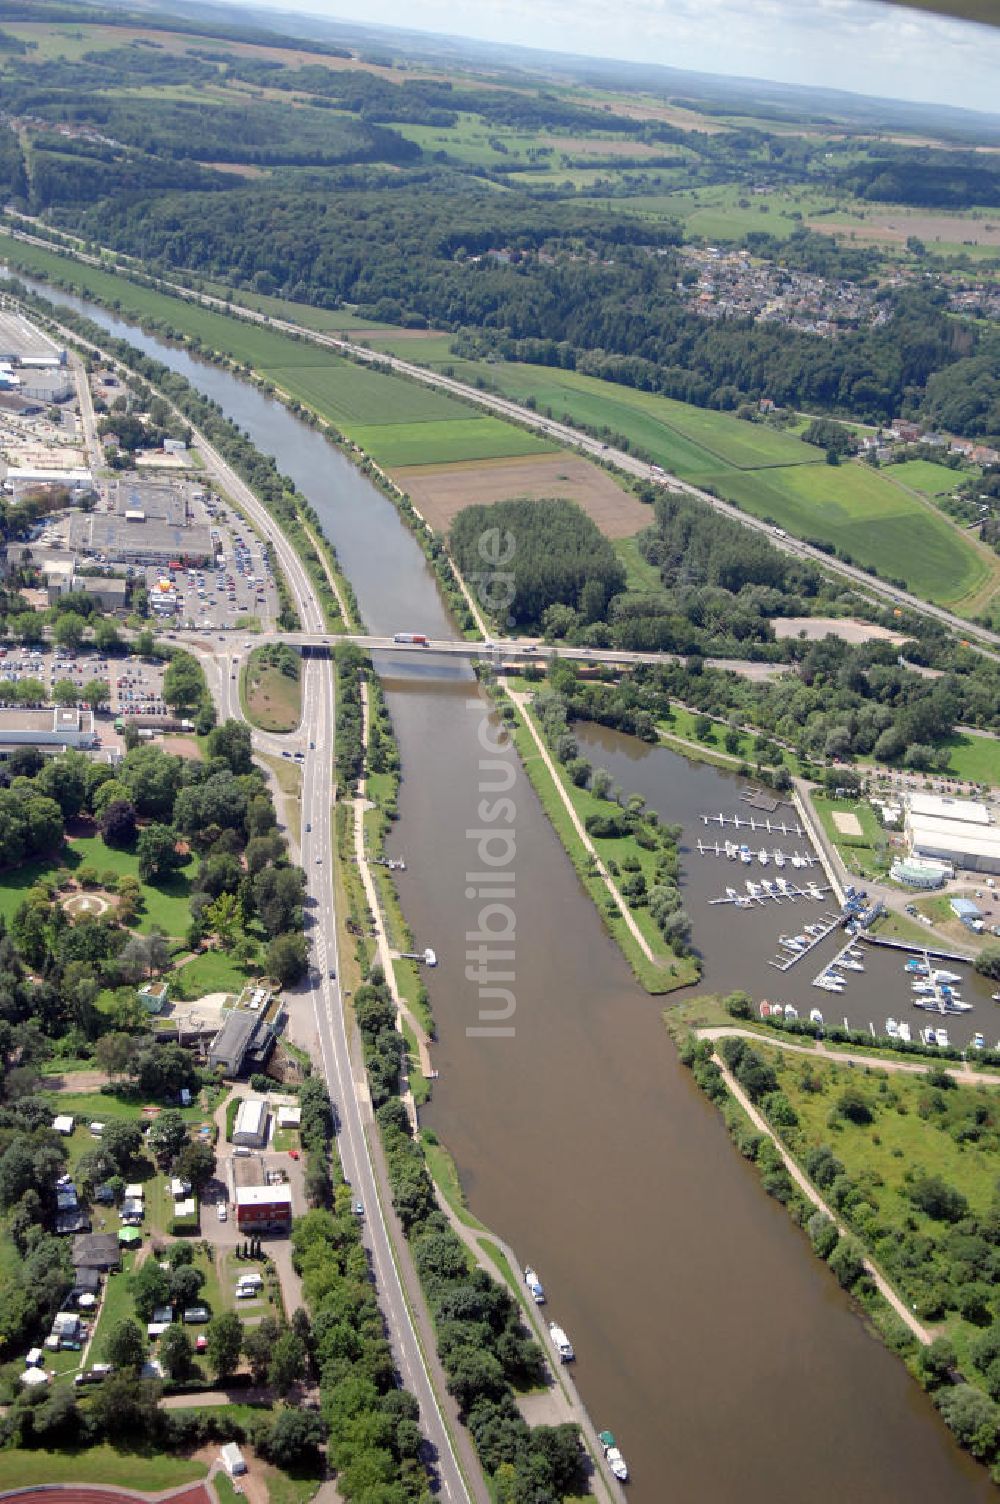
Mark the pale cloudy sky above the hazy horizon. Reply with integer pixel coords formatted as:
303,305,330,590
215,0,1000,113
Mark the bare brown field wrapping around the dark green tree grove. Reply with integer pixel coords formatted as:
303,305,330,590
392,454,653,538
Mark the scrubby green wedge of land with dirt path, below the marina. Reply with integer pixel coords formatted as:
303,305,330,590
665,999,1000,1477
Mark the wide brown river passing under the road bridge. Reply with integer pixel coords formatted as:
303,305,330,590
21,276,995,1504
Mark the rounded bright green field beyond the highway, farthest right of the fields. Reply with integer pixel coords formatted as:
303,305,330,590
704,465,998,609
